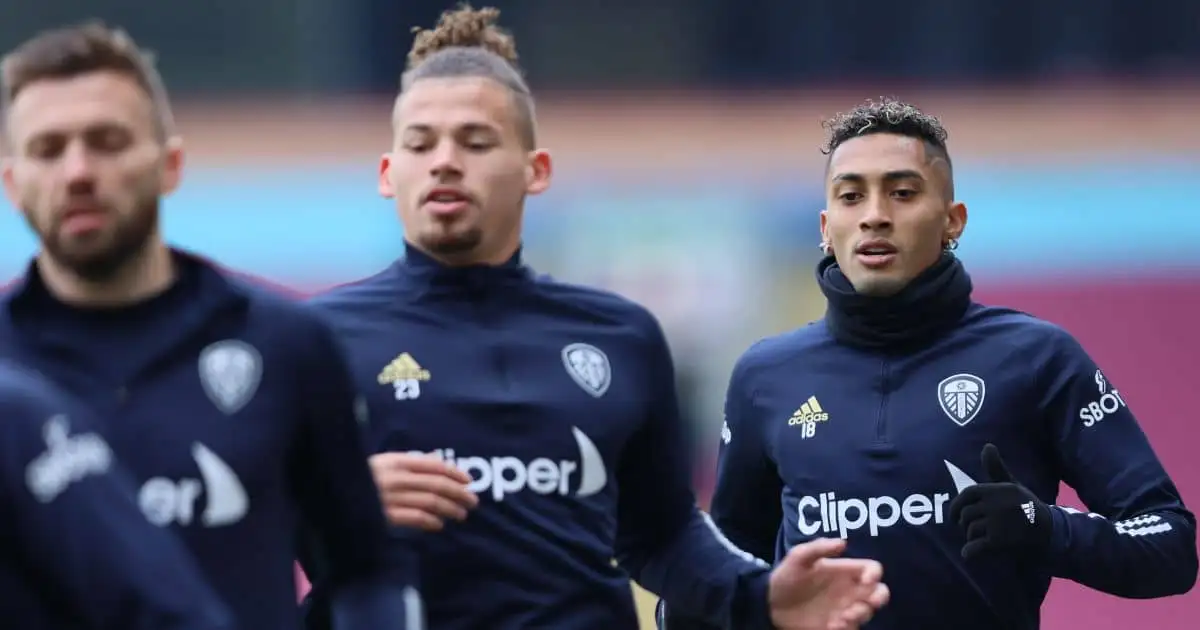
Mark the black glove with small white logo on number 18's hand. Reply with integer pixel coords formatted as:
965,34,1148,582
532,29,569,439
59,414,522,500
950,444,1054,558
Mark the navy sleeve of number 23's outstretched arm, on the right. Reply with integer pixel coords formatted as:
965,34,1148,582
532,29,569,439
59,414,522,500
617,318,772,630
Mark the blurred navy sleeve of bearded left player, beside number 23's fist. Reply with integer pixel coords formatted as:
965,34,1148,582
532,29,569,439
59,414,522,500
292,318,424,630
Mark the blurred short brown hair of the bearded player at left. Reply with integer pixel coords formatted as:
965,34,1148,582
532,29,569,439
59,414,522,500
0,20,175,139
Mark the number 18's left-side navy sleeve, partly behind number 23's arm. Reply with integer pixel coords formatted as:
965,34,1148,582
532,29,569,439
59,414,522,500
658,345,784,630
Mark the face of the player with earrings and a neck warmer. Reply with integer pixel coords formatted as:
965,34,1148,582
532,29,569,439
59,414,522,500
821,133,966,295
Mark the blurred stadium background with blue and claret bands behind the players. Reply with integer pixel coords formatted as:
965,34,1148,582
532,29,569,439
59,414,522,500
0,0,1200,630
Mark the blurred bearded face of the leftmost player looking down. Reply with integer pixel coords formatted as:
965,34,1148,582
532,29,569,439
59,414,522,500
4,72,182,280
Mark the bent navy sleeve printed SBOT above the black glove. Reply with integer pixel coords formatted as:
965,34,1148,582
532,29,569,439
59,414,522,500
1038,330,1196,599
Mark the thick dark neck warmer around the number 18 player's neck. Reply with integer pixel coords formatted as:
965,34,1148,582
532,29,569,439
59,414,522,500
817,253,972,353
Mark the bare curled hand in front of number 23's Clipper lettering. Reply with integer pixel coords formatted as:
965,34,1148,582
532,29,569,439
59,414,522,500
370,452,479,532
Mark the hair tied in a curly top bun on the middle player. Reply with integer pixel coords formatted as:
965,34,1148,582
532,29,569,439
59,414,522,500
400,4,536,149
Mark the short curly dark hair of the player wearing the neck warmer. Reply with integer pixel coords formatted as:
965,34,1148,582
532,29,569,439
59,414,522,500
821,97,954,197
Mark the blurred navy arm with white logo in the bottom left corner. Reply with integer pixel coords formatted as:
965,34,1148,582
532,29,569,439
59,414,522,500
0,390,234,630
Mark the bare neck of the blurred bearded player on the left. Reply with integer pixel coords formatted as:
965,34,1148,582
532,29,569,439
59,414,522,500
37,242,175,307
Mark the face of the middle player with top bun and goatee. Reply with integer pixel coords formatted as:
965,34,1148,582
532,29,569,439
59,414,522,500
379,77,550,263
